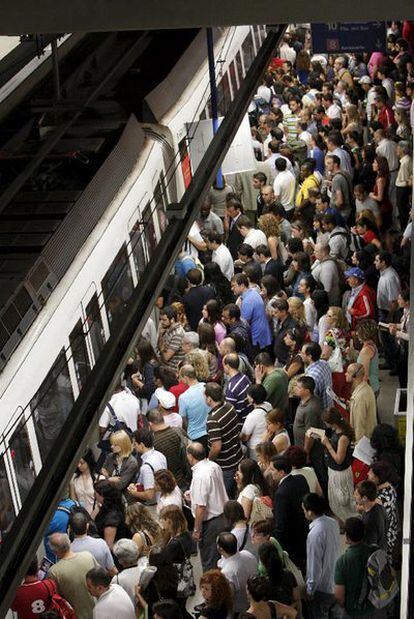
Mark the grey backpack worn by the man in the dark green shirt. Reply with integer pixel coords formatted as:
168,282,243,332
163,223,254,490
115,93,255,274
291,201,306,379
359,548,398,609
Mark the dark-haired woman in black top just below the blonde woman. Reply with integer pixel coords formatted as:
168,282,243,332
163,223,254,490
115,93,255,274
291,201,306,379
94,479,129,549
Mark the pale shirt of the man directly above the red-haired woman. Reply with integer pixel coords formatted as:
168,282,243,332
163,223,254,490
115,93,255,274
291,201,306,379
217,550,257,613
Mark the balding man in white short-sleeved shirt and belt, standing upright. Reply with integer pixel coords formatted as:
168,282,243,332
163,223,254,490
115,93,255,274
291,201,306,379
184,443,228,572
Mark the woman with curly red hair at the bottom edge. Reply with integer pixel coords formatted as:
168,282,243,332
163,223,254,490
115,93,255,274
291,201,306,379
199,570,233,619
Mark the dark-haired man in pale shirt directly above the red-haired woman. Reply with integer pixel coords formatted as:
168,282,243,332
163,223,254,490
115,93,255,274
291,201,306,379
217,533,257,614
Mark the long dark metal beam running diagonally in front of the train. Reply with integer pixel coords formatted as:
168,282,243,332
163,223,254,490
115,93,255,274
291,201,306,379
0,25,285,617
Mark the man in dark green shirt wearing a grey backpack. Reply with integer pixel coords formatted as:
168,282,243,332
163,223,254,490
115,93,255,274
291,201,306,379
335,517,386,619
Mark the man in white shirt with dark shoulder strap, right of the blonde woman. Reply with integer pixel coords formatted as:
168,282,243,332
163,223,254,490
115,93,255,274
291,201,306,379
128,430,168,505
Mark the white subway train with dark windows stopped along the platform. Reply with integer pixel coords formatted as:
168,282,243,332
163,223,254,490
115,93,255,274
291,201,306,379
0,26,266,542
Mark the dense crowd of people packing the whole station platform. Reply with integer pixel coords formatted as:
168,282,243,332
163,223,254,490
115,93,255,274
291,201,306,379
12,22,414,619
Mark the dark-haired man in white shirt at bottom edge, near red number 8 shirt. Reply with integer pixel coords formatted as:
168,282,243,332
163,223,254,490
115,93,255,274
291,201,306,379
86,567,135,619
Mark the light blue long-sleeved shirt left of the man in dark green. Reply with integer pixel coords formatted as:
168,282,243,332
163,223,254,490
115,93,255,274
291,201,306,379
306,516,341,595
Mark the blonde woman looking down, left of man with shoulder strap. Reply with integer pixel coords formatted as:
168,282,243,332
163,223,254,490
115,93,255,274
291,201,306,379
101,430,138,503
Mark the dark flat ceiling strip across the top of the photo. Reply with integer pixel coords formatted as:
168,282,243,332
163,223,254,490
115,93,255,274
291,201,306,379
0,0,414,34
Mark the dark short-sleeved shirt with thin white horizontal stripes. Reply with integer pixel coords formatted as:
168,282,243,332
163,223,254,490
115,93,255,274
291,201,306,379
207,403,243,470
